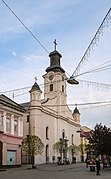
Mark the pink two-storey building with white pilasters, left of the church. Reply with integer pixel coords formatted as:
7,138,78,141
0,95,25,168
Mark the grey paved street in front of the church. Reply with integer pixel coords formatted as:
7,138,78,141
0,163,111,179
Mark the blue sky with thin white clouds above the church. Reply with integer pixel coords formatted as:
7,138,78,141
0,0,111,128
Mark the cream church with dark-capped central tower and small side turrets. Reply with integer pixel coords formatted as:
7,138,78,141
21,47,80,164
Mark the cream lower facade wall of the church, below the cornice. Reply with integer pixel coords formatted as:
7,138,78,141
25,108,80,164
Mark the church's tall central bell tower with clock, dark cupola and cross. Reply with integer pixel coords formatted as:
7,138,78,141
43,40,67,110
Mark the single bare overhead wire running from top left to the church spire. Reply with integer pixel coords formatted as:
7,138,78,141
2,0,49,54
